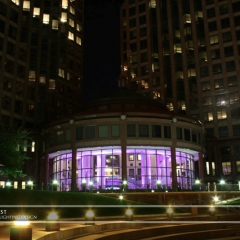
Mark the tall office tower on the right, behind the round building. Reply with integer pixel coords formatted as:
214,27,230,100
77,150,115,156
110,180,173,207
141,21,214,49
120,0,240,183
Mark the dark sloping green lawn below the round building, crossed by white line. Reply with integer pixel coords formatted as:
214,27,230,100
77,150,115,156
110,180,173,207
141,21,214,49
0,189,166,219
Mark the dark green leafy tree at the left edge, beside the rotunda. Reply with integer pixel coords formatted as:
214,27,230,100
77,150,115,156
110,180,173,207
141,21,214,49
0,125,31,178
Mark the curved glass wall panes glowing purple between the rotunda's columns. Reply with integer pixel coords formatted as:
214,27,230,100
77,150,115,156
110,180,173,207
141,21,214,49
53,146,194,191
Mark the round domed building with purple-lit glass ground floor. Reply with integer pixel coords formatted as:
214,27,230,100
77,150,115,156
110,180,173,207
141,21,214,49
40,88,205,191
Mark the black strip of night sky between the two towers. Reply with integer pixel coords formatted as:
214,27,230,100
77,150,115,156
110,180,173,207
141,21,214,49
83,0,122,101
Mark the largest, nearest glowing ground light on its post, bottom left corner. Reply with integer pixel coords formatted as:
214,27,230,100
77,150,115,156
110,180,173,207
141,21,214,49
10,216,32,240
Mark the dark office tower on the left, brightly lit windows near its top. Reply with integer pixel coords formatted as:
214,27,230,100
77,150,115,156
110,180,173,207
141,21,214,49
0,0,83,128
